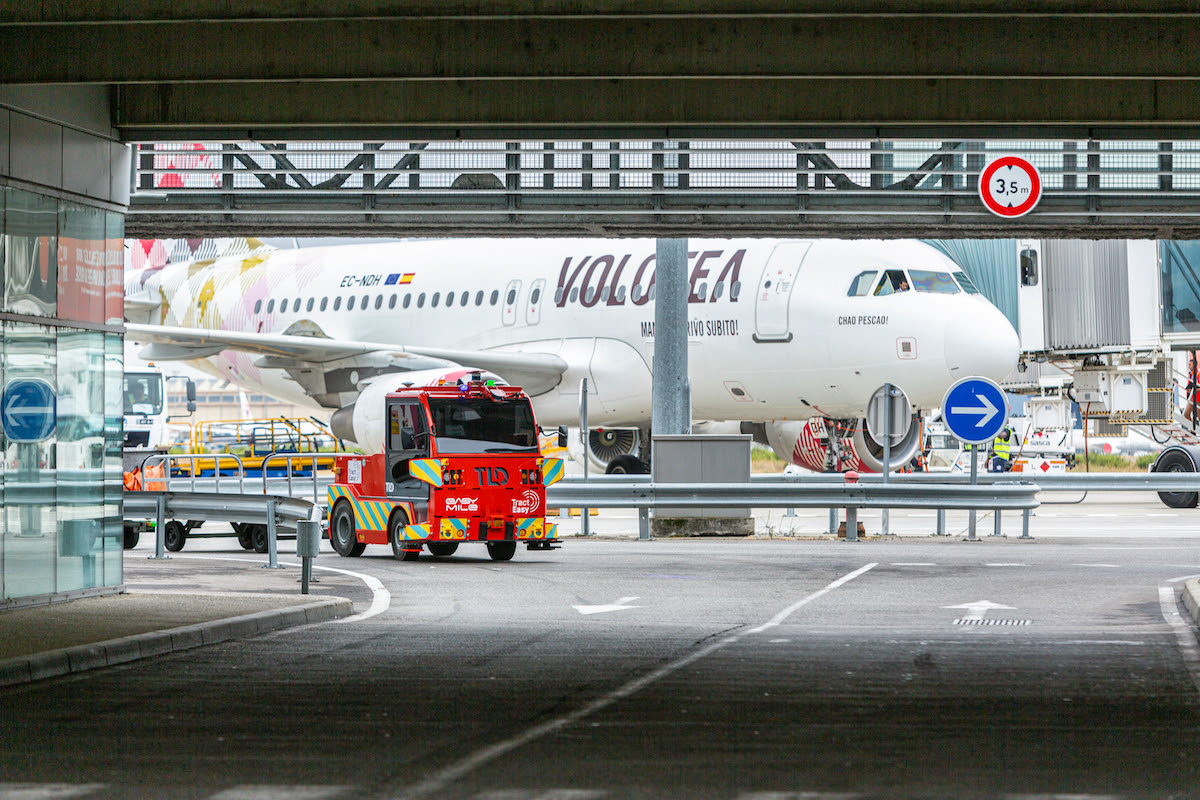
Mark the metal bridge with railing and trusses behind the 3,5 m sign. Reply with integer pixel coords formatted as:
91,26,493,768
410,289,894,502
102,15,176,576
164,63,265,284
126,139,1200,239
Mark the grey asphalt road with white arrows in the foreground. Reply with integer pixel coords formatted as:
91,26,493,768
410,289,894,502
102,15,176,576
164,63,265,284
0,503,1200,800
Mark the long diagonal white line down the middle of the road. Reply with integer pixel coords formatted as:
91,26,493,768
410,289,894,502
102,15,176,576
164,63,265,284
395,564,876,800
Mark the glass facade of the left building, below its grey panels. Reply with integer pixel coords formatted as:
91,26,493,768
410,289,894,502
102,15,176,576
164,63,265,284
0,187,124,602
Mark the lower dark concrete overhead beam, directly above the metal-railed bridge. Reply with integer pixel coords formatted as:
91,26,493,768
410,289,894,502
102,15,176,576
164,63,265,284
115,78,1200,140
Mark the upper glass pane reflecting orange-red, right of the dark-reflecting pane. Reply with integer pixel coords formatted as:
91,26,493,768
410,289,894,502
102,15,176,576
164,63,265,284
58,201,108,323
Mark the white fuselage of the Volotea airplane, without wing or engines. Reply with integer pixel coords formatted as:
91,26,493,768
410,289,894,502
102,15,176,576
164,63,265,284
130,239,1018,427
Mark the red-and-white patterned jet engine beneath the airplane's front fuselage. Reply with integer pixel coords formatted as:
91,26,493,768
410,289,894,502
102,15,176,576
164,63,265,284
764,415,920,473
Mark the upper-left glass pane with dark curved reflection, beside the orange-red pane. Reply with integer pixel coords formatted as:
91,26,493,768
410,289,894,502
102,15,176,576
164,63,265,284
4,190,59,317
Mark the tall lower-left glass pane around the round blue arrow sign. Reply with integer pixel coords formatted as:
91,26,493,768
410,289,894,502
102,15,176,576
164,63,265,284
4,323,58,597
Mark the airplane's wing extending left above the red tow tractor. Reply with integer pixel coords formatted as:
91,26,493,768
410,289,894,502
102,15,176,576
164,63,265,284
125,323,568,395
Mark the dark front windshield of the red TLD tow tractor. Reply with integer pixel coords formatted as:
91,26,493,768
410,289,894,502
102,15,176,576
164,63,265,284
430,397,538,453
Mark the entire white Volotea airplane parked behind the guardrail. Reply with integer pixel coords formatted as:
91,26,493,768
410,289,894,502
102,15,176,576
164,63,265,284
126,239,1019,471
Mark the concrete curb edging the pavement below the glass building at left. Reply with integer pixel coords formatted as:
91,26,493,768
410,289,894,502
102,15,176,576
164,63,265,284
0,597,354,687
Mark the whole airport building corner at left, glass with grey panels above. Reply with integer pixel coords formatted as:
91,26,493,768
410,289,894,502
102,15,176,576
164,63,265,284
0,86,130,607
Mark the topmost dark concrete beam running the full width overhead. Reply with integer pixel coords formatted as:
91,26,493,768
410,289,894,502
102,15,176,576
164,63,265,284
7,14,1200,83
